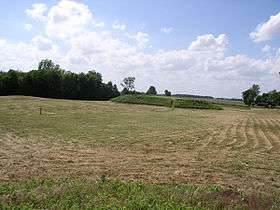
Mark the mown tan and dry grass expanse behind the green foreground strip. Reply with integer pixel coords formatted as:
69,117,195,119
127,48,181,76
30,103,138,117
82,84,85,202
0,97,280,193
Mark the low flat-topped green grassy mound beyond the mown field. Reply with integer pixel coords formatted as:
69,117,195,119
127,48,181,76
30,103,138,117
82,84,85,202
111,95,222,110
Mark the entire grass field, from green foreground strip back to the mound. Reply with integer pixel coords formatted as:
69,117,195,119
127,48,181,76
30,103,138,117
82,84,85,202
0,96,280,209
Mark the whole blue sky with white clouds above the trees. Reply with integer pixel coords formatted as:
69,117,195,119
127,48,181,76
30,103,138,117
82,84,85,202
0,0,280,98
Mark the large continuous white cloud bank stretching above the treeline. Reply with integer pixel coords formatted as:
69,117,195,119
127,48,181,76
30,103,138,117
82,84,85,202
4,0,280,97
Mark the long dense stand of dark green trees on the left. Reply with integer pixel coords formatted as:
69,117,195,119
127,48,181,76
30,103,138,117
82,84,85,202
0,60,119,100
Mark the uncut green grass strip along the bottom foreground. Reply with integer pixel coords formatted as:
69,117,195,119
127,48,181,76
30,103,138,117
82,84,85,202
0,179,279,209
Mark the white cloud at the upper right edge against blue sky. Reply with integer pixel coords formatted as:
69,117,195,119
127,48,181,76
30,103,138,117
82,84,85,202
250,13,280,42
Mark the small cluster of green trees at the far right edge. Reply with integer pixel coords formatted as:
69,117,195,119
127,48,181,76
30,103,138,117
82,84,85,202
242,84,280,108
